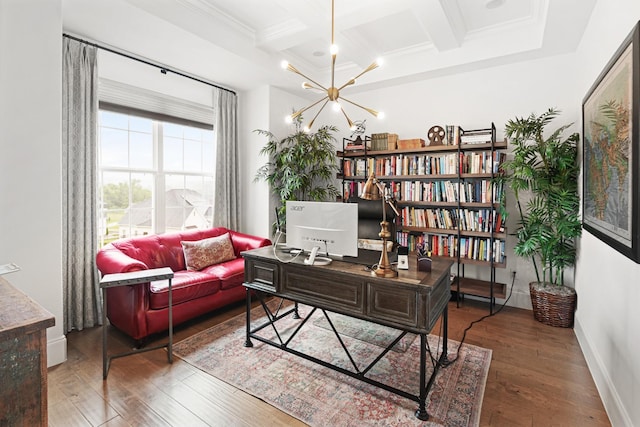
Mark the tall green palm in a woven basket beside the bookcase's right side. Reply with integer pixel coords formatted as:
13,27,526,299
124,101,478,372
503,108,582,327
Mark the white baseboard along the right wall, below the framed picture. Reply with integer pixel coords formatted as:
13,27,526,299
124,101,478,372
573,318,633,426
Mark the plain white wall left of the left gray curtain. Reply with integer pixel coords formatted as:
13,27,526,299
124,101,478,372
0,0,67,366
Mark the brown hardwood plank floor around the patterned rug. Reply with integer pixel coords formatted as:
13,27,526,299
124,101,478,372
49,300,610,427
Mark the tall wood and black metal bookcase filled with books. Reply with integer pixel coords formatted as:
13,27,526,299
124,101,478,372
338,124,507,307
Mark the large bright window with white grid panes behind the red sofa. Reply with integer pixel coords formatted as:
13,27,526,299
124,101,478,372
98,109,215,246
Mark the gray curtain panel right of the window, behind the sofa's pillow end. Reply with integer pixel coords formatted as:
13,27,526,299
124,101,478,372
213,88,240,230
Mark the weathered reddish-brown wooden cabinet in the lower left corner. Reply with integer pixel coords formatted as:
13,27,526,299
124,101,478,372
0,277,55,426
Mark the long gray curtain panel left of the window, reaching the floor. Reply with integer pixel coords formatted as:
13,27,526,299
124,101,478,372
62,37,102,332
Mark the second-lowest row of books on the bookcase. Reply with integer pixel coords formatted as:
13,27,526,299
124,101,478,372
400,206,504,233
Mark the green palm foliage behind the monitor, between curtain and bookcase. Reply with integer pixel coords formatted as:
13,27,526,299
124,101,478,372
254,116,340,234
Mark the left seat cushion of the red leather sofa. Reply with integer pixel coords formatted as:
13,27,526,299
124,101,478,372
149,270,220,310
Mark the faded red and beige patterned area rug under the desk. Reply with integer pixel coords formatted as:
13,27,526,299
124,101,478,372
173,306,491,427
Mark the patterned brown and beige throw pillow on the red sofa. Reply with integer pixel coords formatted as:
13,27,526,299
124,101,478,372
180,233,236,270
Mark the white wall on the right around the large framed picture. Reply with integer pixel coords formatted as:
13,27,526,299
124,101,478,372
574,0,640,426
